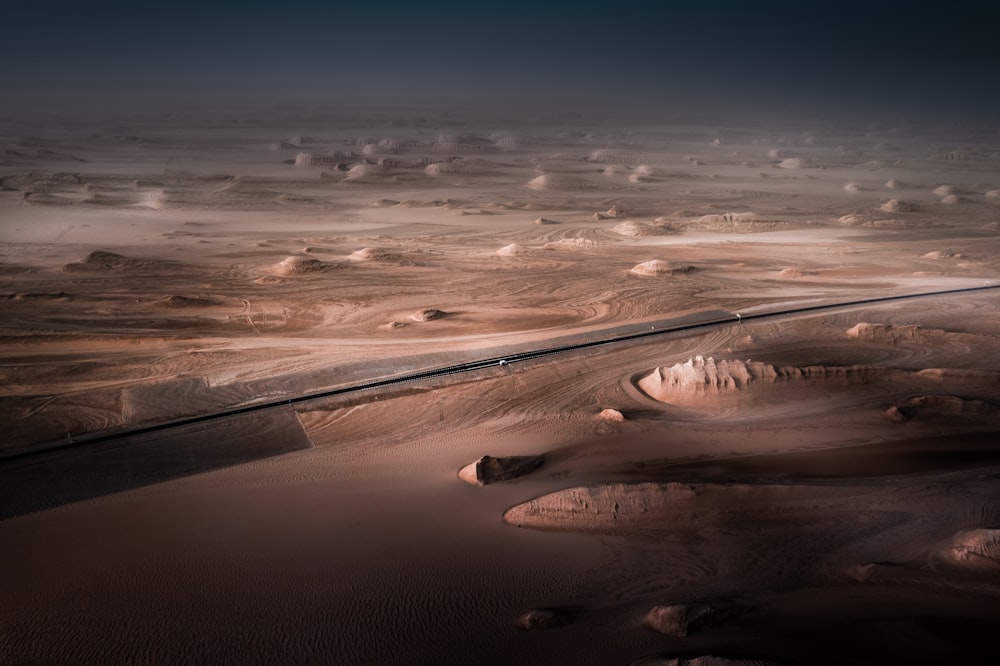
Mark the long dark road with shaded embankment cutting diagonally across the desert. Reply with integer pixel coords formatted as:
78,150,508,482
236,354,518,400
0,285,1000,520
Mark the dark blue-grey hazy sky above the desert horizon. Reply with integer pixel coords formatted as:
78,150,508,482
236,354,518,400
0,0,1000,116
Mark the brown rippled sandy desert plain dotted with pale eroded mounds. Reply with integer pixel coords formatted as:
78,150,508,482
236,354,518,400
0,111,1000,664
